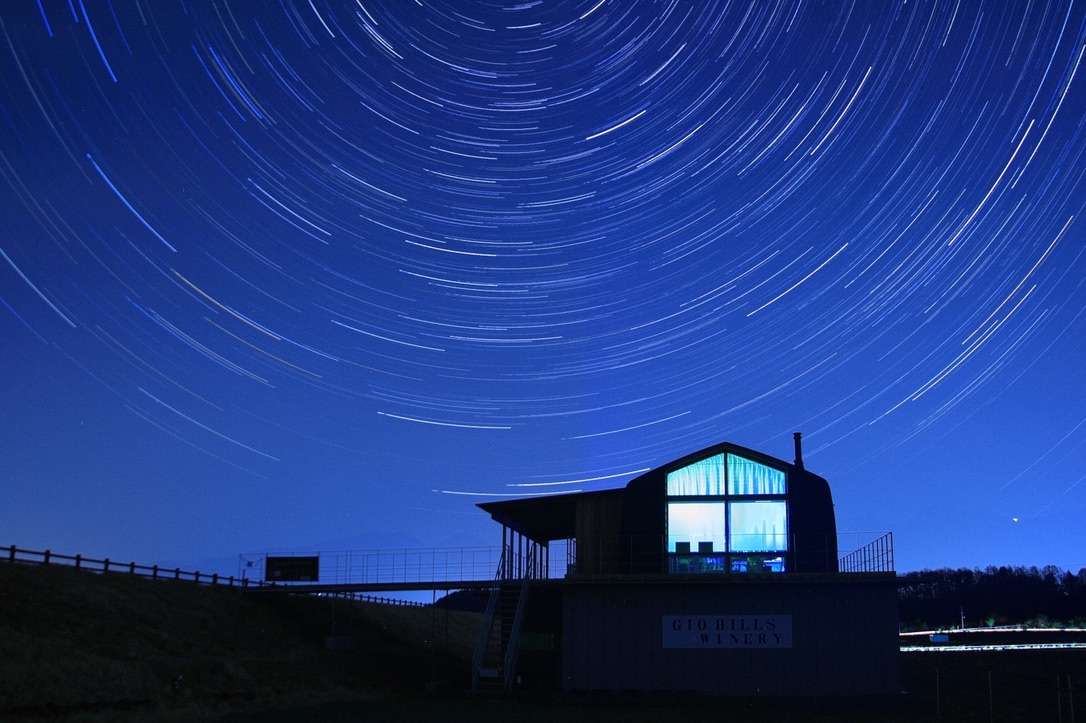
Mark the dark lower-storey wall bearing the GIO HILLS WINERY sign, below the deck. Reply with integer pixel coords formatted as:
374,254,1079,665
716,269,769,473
561,573,900,696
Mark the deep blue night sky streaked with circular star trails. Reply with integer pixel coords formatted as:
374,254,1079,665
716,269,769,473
0,0,1086,572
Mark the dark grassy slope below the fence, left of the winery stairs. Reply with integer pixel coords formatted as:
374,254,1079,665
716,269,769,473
0,563,480,720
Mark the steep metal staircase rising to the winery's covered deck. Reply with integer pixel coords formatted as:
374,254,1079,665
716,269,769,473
471,547,535,697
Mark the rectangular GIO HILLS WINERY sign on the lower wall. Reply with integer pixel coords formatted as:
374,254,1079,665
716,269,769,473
664,616,792,648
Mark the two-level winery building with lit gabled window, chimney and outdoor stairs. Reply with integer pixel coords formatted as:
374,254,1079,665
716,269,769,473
472,433,899,696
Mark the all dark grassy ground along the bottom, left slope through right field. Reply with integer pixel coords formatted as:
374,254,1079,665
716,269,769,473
0,565,1086,723
